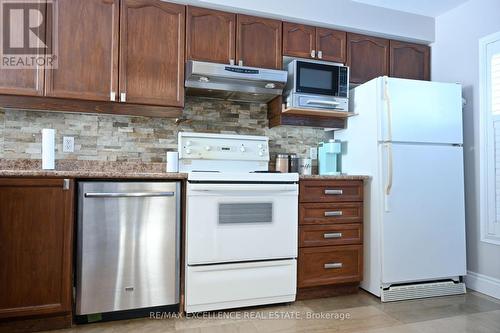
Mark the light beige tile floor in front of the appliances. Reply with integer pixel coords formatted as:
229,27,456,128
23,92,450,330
44,291,500,333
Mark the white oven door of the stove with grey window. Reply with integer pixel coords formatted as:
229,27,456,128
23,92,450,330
186,183,298,265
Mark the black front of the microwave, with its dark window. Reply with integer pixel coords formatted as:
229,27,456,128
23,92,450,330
295,61,347,97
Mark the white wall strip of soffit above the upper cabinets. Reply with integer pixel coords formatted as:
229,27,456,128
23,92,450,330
173,0,434,43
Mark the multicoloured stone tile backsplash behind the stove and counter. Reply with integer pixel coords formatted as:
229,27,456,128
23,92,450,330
0,97,326,162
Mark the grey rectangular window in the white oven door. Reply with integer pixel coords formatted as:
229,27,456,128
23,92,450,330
219,202,273,224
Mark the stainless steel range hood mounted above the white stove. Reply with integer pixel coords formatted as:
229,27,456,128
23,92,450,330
185,60,288,103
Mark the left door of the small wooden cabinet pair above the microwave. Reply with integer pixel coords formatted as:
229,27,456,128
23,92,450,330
283,22,316,58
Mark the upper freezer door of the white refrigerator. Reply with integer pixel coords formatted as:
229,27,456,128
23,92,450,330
379,77,463,144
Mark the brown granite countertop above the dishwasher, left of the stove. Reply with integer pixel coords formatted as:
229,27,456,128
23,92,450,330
0,160,187,179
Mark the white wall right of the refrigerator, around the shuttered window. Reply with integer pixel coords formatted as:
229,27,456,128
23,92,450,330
432,0,500,283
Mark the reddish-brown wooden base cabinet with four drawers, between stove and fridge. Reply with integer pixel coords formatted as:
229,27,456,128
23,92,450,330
297,179,363,299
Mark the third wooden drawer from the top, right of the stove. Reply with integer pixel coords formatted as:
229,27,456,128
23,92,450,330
299,223,363,247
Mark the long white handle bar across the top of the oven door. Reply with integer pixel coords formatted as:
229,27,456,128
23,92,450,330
188,184,298,194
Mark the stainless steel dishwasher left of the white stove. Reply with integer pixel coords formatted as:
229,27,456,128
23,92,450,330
76,181,180,316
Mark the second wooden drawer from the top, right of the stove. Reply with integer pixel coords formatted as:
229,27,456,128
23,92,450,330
299,202,363,225
